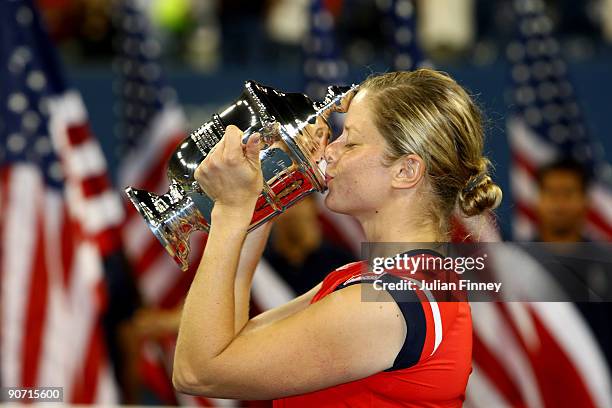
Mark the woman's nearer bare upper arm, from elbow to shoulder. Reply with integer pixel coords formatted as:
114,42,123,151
173,278,406,399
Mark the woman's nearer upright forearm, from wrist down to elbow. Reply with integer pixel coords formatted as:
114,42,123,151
174,206,252,382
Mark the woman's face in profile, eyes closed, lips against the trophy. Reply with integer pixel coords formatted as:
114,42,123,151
325,90,392,216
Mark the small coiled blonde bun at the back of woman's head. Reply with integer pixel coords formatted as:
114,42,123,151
458,172,502,217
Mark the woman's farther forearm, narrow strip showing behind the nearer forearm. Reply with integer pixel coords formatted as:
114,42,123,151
234,222,272,333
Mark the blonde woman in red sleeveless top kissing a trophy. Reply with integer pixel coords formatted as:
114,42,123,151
173,69,501,407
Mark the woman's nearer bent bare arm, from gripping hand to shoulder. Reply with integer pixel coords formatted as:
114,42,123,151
173,127,406,399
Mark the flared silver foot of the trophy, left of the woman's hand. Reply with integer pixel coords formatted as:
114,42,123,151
125,185,209,271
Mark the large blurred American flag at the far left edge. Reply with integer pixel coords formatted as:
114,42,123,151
0,0,123,404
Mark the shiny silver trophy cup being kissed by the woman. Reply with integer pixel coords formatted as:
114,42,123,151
125,81,357,270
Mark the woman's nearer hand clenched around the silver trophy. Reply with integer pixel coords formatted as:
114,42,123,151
194,125,263,207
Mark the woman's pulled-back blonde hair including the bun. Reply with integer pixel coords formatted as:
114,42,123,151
360,69,502,235
